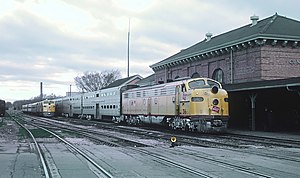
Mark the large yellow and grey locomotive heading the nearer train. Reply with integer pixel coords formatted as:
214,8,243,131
119,78,229,132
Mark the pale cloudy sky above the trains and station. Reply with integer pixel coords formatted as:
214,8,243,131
0,0,300,102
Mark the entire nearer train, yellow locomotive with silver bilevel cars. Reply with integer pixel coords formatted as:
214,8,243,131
52,78,229,132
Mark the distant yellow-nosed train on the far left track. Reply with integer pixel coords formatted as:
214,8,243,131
22,100,55,117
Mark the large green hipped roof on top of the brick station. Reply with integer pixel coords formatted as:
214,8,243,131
150,13,300,71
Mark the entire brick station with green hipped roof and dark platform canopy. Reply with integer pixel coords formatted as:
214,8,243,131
150,13,300,131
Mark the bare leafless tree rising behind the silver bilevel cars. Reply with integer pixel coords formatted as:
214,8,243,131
74,70,121,92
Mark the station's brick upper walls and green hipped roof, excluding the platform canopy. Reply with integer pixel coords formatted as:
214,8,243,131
150,14,300,84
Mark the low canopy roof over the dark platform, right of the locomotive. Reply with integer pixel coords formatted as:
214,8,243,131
223,77,300,92
